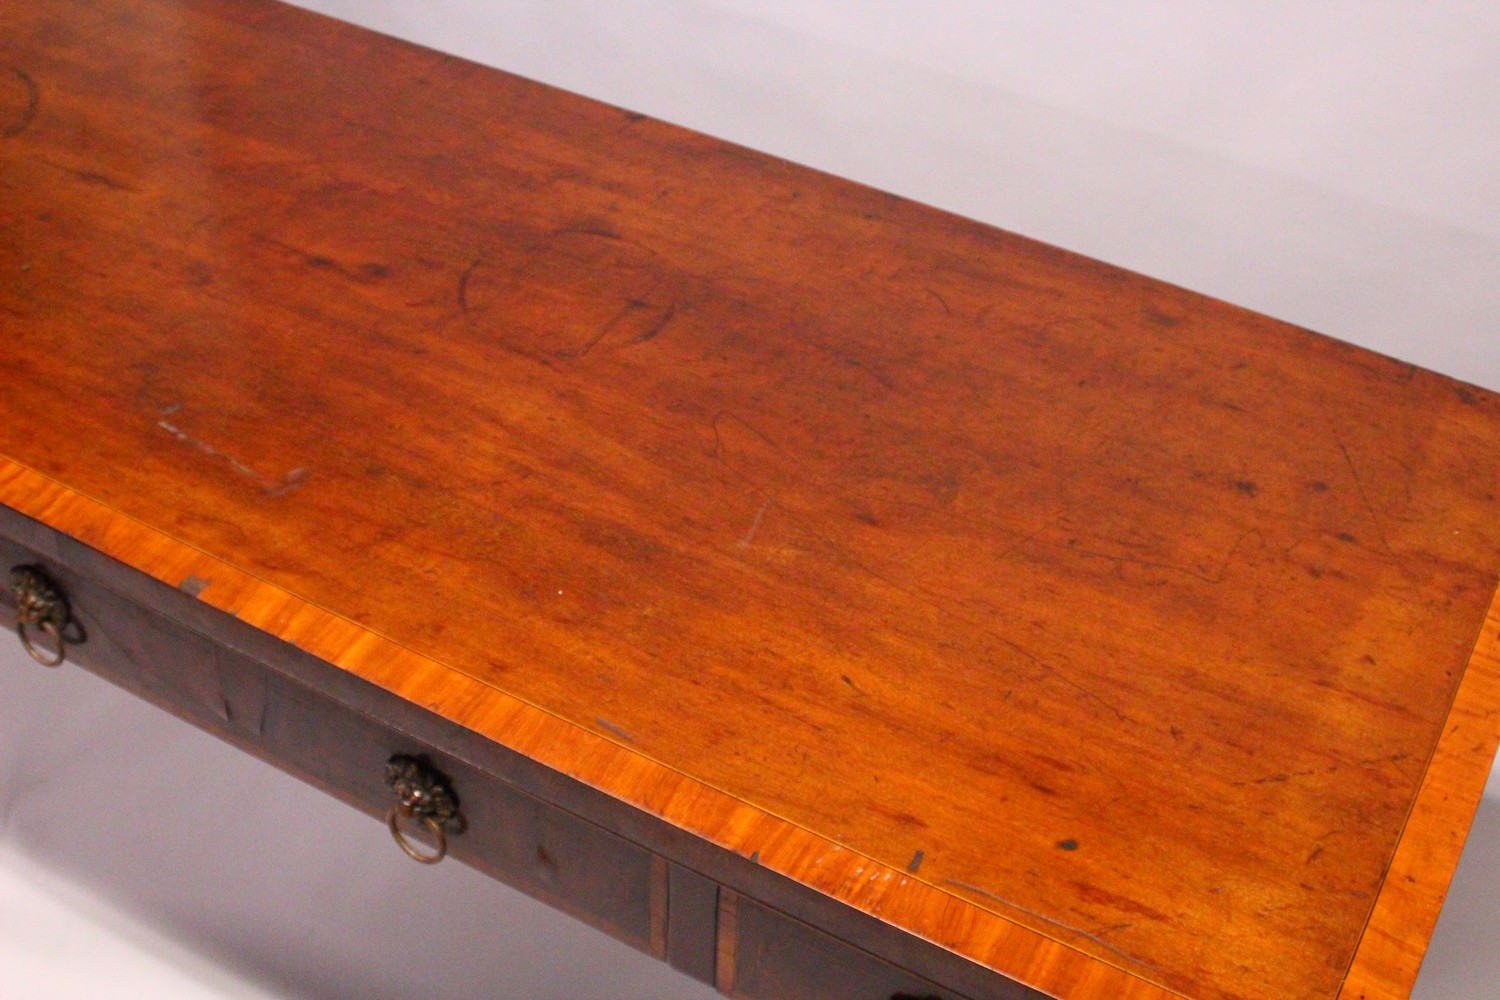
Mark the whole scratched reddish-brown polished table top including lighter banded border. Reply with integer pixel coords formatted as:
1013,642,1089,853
0,0,1500,997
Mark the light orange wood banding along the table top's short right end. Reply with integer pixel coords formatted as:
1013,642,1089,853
1338,581,1500,1000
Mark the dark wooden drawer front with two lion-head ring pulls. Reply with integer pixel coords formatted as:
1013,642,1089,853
0,537,668,957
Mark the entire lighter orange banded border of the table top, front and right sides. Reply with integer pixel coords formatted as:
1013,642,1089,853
14,456,1500,1000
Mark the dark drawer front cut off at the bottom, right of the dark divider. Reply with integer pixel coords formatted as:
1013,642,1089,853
717,889,963,1000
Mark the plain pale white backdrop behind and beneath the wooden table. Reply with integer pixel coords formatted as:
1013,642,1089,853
0,0,1500,1000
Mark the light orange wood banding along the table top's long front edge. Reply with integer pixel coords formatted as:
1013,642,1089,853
0,456,1182,1000
